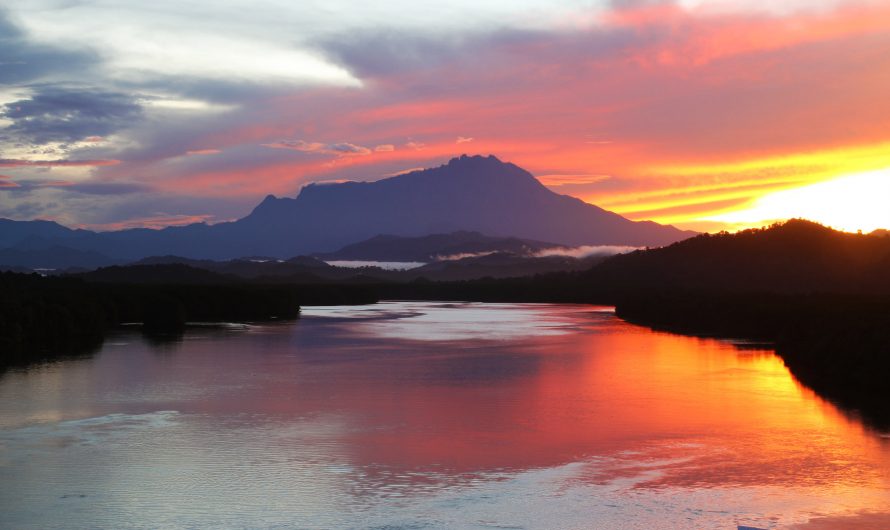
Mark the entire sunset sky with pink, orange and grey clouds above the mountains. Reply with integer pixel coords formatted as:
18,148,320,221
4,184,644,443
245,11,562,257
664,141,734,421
0,0,890,231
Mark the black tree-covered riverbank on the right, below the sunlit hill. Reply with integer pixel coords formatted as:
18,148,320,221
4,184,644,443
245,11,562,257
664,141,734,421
615,293,890,427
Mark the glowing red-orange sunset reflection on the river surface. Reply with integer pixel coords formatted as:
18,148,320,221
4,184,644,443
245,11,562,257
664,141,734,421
286,306,888,496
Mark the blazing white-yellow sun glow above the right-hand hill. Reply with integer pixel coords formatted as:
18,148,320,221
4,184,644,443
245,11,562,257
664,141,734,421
706,168,890,232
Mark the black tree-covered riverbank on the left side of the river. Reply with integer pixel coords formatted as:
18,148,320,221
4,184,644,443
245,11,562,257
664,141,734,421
0,272,377,370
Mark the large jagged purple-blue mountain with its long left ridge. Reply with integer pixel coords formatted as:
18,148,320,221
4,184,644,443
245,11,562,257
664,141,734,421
0,155,695,260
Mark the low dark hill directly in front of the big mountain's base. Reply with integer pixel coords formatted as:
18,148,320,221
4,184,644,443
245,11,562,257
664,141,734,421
316,231,561,262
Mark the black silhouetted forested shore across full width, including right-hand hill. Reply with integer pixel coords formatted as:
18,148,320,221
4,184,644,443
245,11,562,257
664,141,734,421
0,220,890,425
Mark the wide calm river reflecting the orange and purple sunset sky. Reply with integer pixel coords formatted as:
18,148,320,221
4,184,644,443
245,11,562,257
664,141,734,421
0,303,890,529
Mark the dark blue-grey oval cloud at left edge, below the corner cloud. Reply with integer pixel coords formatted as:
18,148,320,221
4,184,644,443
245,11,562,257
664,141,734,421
0,86,142,144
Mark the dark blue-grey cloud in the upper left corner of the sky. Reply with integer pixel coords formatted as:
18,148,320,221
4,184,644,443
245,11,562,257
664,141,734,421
0,8,99,85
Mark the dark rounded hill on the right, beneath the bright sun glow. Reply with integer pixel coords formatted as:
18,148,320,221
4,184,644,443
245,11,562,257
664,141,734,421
585,220,890,294
